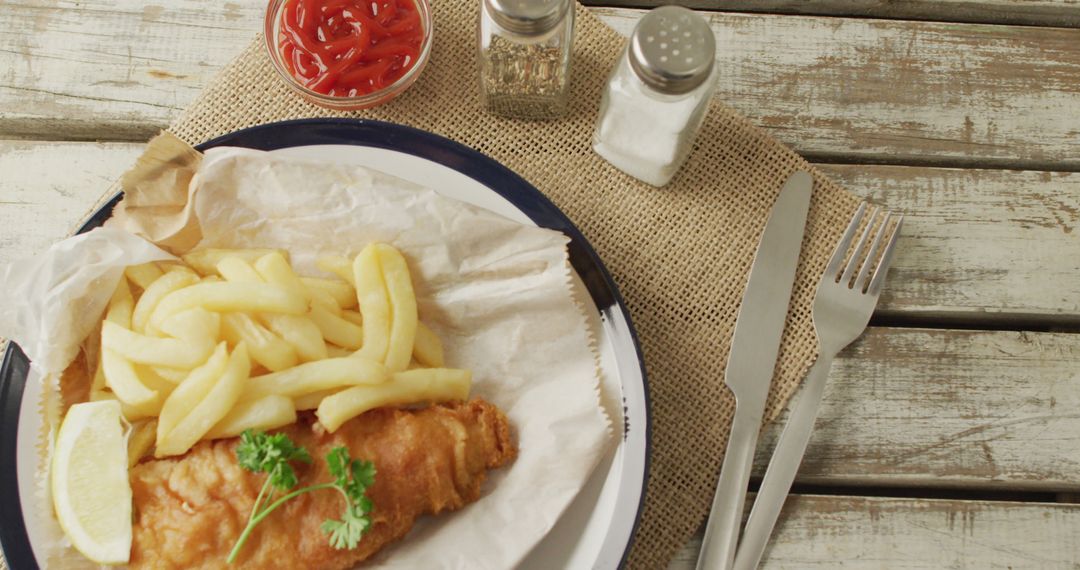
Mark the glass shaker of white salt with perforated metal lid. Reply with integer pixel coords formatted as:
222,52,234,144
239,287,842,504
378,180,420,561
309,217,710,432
593,6,716,187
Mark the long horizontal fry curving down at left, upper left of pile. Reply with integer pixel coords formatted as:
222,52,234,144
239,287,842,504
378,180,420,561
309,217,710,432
147,275,308,326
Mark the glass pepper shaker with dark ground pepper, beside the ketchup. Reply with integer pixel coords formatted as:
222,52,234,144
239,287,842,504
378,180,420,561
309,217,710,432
480,0,573,119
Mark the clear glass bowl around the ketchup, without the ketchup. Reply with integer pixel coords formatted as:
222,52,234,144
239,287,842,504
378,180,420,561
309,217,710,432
262,0,432,111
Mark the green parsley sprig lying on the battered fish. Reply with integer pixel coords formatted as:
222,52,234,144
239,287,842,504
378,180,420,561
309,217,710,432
226,430,375,564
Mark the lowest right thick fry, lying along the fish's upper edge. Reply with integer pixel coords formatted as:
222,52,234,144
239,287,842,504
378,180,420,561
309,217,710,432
315,368,472,432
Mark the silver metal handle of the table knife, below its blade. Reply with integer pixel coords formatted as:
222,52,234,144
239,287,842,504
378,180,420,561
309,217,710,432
698,403,761,570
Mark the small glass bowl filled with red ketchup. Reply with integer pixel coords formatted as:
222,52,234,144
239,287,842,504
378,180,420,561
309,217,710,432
265,0,432,111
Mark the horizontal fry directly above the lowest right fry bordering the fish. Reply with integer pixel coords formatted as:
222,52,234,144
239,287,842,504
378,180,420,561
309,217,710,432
244,356,388,399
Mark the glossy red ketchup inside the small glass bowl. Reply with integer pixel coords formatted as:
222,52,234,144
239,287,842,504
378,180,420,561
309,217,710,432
278,0,423,97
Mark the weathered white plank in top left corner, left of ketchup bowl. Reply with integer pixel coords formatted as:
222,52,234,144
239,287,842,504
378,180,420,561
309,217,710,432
0,0,266,140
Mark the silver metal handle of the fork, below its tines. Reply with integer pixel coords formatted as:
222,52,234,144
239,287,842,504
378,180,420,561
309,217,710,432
734,354,833,570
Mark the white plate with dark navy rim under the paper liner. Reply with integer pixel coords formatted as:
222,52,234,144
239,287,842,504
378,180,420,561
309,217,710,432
0,119,649,570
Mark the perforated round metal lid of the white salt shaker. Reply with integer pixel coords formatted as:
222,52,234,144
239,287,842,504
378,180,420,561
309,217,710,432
630,5,716,94
